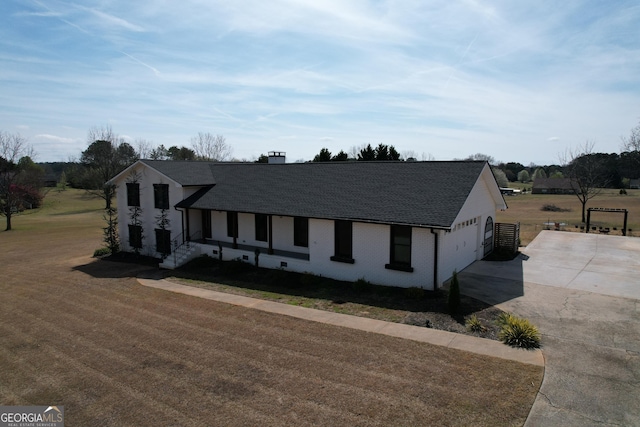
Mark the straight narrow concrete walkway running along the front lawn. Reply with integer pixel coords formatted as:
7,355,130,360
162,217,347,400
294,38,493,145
138,278,544,366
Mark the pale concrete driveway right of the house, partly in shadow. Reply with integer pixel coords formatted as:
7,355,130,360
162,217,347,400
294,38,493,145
459,231,640,426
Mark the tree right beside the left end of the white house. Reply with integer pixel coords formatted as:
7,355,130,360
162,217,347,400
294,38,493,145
80,125,138,209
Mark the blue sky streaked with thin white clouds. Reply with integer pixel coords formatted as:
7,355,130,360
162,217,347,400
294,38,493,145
0,0,640,165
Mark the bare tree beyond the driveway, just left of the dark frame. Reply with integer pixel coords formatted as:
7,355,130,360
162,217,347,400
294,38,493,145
561,141,607,222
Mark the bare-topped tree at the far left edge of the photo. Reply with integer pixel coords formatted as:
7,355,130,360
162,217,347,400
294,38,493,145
0,131,41,231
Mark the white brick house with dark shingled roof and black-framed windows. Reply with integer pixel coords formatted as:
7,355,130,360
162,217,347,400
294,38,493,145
110,160,506,289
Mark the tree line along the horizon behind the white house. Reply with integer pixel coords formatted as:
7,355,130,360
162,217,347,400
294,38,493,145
5,120,640,234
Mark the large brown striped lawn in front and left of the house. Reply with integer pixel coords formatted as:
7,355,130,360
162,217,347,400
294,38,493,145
0,190,542,426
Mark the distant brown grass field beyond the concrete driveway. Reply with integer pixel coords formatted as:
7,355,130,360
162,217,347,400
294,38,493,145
497,189,640,246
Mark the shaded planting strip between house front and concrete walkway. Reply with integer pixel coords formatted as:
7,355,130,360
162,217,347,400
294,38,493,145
154,258,502,340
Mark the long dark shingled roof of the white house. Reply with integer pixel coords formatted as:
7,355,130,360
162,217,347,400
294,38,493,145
172,161,486,228
